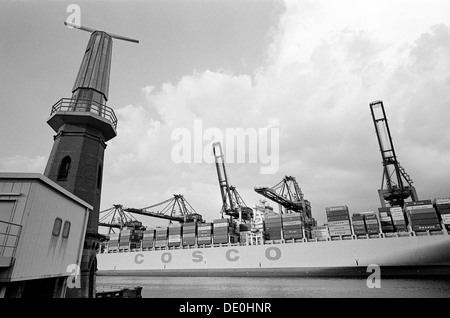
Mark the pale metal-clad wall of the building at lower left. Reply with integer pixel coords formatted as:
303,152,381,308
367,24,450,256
0,179,88,281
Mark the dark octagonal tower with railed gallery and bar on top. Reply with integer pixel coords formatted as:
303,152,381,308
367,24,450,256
44,23,137,297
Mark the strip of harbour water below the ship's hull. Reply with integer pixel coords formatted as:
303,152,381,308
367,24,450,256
97,276,450,298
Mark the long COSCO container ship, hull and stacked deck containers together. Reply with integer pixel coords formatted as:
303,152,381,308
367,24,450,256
97,199,450,278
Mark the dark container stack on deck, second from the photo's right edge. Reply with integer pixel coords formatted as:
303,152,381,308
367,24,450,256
405,200,441,232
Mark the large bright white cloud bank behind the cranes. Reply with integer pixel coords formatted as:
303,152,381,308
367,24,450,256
103,1,450,226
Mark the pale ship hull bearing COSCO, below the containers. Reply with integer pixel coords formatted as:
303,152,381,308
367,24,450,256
97,235,450,278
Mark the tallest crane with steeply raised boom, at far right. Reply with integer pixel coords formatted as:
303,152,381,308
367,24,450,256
370,101,418,207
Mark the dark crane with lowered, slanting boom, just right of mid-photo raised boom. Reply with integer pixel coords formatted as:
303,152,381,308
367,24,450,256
255,176,312,218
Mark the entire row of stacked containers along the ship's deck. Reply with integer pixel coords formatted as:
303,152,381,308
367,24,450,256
108,198,450,251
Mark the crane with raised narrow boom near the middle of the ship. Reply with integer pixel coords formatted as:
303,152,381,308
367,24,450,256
212,142,253,222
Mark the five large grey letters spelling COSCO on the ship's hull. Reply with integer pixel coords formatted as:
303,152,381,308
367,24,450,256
134,246,281,264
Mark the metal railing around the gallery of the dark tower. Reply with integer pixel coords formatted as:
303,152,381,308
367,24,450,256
50,98,117,129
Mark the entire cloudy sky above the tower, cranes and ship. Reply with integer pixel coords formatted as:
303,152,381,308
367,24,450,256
0,0,450,224
